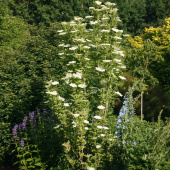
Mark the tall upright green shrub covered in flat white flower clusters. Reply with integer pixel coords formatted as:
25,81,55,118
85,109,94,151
44,1,126,169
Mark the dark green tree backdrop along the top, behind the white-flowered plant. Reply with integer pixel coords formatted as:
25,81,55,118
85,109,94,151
5,0,170,35
